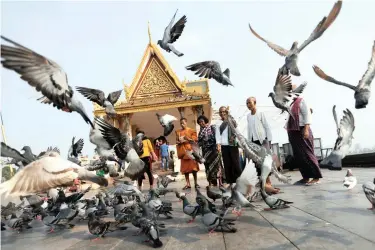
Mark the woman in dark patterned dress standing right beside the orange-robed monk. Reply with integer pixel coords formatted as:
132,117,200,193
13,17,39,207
197,115,222,186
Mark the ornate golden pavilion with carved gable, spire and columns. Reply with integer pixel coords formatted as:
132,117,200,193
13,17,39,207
94,23,212,145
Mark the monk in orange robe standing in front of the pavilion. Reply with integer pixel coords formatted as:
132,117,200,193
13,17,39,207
176,118,200,190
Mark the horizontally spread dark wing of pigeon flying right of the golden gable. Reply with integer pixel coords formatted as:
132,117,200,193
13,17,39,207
186,61,223,82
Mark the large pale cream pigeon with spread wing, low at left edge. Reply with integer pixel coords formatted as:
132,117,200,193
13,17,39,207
0,152,108,196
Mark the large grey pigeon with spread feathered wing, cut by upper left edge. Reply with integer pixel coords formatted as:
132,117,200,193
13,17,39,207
1,36,94,127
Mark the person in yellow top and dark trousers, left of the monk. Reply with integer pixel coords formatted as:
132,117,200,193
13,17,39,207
137,130,157,190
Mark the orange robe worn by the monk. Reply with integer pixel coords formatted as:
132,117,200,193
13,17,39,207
176,128,199,174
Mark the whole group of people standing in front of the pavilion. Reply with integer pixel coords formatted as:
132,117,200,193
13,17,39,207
137,94,322,197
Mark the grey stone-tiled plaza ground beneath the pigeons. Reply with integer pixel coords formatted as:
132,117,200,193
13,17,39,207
1,168,375,250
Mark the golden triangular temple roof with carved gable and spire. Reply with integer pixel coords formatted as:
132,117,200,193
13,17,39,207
94,24,211,114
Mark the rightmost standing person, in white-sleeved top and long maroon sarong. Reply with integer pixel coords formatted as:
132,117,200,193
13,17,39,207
286,85,323,185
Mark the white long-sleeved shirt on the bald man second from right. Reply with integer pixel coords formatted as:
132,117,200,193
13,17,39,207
247,111,272,143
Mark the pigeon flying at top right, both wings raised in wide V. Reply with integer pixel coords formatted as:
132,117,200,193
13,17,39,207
249,0,342,76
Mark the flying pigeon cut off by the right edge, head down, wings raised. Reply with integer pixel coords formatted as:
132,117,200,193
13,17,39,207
313,41,375,109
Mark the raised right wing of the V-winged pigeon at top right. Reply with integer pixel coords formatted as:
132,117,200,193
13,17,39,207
298,0,342,52
